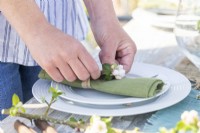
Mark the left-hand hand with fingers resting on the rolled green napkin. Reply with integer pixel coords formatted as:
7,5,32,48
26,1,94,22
26,25,100,82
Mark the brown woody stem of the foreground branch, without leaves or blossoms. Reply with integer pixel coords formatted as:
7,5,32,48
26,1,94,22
2,109,87,129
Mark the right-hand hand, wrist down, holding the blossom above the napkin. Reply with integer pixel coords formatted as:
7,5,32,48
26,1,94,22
93,22,136,72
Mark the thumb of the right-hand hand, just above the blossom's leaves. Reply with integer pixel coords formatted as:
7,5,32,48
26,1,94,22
99,48,116,64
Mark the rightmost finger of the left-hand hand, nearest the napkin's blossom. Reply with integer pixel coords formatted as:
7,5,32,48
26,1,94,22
79,50,101,79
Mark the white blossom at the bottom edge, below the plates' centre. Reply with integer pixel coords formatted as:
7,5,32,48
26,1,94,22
85,119,108,133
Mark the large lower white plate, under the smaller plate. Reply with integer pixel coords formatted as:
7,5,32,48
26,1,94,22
32,63,191,116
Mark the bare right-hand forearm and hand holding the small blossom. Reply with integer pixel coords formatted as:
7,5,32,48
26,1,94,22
84,0,136,72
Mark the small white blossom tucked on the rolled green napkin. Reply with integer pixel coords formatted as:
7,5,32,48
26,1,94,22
112,65,126,79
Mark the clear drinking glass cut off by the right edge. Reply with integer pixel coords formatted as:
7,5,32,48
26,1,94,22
174,0,200,69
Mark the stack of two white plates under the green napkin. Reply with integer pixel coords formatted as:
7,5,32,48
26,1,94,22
32,63,191,116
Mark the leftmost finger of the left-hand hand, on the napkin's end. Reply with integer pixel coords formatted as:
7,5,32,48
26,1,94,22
43,65,64,82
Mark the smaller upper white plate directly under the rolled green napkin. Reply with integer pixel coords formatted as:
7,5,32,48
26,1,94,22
51,72,170,105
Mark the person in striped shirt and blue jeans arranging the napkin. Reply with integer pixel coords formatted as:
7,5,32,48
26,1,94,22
0,0,136,119
